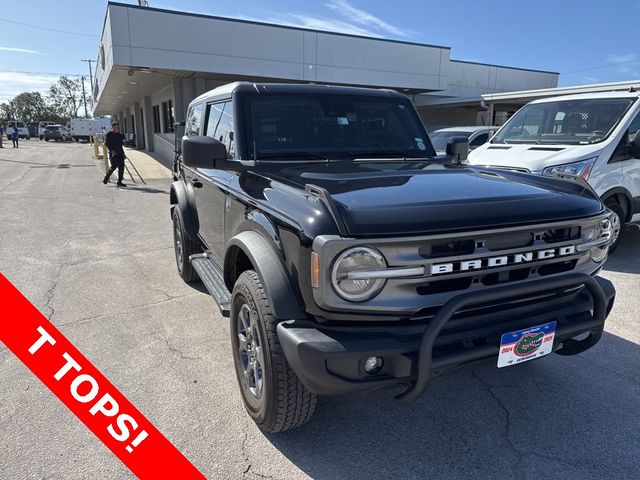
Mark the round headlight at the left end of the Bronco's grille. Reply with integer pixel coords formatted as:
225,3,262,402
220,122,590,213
331,247,387,302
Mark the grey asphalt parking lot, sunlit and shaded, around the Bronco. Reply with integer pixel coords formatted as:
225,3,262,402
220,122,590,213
0,140,640,480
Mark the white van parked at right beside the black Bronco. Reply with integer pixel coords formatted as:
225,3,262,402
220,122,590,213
469,91,640,249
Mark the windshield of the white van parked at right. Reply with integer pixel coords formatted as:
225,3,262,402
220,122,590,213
491,98,634,145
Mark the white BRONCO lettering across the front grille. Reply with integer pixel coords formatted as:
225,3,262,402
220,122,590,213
431,245,576,275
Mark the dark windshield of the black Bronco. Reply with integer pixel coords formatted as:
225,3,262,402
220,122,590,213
244,93,435,160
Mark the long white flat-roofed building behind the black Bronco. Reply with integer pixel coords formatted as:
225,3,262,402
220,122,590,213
93,2,558,163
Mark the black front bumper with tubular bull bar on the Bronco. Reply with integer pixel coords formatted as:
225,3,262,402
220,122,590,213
277,274,615,401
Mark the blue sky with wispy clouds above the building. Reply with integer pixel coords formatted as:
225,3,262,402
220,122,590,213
0,0,640,102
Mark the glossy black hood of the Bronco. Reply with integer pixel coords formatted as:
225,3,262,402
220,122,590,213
262,162,603,236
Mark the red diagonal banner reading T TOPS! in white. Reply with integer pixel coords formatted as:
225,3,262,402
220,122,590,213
0,274,205,479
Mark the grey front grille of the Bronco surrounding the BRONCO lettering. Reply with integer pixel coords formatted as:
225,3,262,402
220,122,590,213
314,215,604,316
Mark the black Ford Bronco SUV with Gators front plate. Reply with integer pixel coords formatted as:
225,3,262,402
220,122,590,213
170,83,615,432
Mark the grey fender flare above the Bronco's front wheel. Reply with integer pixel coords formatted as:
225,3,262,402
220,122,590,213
224,231,306,320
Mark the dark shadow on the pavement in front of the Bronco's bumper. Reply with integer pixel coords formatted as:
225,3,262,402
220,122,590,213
256,333,640,479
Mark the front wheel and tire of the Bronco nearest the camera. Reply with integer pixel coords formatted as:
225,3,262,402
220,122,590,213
230,270,318,432
